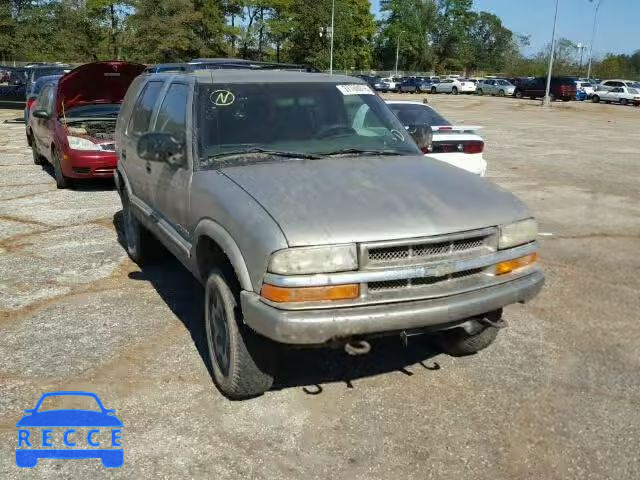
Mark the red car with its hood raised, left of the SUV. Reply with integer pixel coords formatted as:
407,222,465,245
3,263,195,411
29,61,144,188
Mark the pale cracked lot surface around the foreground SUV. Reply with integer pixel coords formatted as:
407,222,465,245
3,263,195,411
0,95,640,480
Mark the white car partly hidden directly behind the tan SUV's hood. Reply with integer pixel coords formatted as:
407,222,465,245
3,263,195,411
386,100,487,176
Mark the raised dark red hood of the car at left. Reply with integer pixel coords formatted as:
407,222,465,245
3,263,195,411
56,62,145,114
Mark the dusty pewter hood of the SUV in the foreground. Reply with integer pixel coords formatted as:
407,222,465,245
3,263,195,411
222,156,530,246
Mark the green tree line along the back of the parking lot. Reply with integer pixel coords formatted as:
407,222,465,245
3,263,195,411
0,0,640,77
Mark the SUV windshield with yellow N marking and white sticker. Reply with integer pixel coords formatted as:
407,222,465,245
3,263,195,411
197,83,420,163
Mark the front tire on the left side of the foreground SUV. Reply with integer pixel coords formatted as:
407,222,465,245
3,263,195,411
204,269,276,400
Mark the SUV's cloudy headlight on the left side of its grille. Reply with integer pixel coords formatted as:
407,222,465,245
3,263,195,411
269,244,358,275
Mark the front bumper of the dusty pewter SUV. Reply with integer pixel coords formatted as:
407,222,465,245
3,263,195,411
240,269,544,345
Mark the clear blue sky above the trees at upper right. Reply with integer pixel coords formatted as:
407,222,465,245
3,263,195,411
372,0,640,57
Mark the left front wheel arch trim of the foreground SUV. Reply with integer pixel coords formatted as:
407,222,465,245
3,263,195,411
191,219,253,291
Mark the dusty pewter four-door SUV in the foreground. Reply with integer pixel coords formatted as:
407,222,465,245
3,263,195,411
116,70,544,398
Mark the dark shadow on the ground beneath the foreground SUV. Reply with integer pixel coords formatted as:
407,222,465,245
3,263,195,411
114,211,440,395
